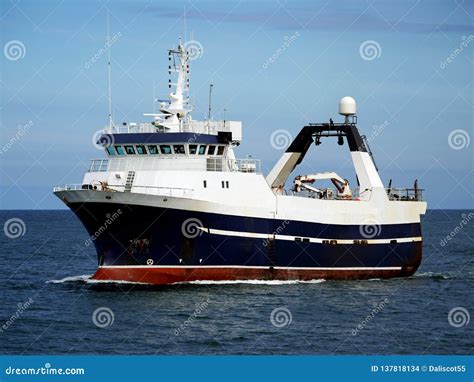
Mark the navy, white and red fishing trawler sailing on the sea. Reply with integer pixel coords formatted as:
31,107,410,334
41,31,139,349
54,41,426,284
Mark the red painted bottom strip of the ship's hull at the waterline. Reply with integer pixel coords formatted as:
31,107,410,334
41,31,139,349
93,266,416,285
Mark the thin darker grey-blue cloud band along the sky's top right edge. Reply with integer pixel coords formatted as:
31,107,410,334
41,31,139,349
123,2,474,34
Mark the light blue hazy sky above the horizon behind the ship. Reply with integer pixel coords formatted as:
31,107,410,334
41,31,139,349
0,0,474,209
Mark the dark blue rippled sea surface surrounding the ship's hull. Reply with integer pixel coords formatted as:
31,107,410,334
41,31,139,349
0,210,474,354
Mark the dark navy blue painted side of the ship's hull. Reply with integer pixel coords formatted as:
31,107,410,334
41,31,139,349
69,203,422,278
